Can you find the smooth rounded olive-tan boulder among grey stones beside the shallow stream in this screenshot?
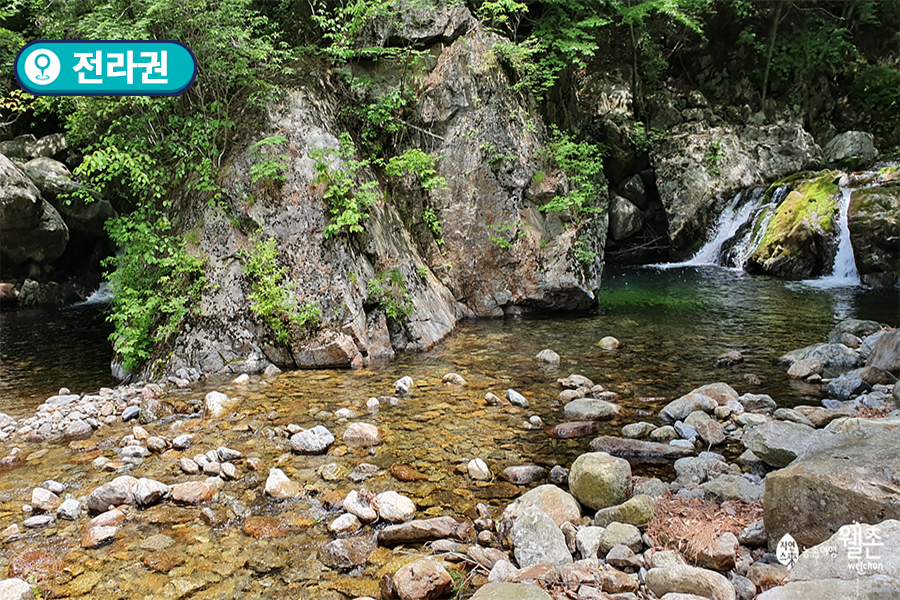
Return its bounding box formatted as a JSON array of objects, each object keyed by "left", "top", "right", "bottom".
[{"left": 569, "top": 452, "right": 631, "bottom": 510}]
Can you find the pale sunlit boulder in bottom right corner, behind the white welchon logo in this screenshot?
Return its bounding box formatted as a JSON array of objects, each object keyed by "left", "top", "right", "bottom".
[{"left": 758, "top": 519, "right": 900, "bottom": 600}]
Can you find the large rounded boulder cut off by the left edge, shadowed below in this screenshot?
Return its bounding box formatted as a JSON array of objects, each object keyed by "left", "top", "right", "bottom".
[{"left": 0, "top": 154, "right": 69, "bottom": 264}]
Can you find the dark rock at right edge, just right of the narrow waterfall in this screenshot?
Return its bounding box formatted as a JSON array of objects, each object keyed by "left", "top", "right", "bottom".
[{"left": 847, "top": 186, "right": 900, "bottom": 289}]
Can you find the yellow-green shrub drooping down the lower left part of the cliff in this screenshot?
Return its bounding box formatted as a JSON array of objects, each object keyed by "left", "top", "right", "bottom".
[{"left": 238, "top": 233, "right": 322, "bottom": 344}]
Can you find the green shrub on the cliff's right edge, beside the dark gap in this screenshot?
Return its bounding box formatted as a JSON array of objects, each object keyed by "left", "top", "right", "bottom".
[{"left": 541, "top": 127, "right": 603, "bottom": 217}]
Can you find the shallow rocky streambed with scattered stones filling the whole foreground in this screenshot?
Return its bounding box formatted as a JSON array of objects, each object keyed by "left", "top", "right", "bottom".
[{"left": 0, "top": 321, "right": 900, "bottom": 600}]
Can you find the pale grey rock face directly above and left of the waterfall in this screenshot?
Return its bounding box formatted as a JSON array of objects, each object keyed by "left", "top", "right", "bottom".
[{"left": 650, "top": 122, "right": 821, "bottom": 258}]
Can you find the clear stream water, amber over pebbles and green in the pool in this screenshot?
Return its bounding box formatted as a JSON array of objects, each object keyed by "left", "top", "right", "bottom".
[{"left": 0, "top": 266, "right": 900, "bottom": 600}]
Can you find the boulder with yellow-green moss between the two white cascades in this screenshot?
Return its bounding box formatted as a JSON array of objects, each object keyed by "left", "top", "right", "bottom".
[{"left": 747, "top": 171, "right": 840, "bottom": 279}]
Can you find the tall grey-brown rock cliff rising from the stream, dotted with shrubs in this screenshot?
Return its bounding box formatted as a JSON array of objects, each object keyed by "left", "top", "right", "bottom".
[{"left": 158, "top": 31, "right": 606, "bottom": 375}]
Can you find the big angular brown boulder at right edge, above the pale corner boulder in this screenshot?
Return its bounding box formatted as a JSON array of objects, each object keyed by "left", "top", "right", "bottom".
[{"left": 754, "top": 418, "right": 900, "bottom": 547}]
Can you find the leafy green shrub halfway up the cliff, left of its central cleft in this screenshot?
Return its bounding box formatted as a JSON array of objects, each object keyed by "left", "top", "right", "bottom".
[{"left": 310, "top": 132, "right": 380, "bottom": 238}]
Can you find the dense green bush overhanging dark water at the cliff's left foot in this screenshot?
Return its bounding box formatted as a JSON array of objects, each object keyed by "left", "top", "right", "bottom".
[{"left": 105, "top": 209, "right": 206, "bottom": 371}]
